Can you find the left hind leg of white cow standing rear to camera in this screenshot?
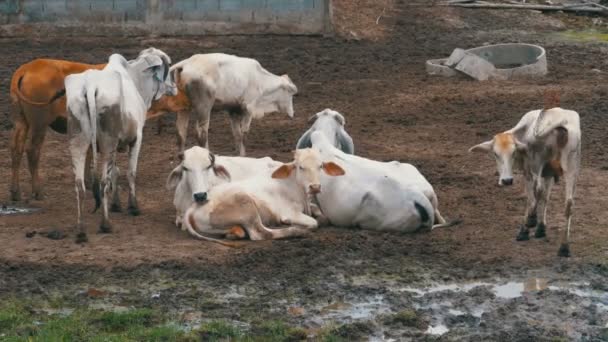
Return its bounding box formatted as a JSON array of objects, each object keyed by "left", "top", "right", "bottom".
[{"left": 69, "top": 133, "right": 90, "bottom": 243}]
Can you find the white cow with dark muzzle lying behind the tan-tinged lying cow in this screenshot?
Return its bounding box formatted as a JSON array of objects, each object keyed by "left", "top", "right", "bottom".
[{"left": 167, "top": 146, "right": 282, "bottom": 229}]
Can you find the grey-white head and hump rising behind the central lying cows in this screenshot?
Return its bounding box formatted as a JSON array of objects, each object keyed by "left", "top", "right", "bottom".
[{"left": 296, "top": 109, "right": 355, "bottom": 154}]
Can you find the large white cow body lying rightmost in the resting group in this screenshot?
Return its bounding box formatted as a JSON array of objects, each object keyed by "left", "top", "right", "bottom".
[{"left": 311, "top": 131, "right": 458, "bottom": 232}]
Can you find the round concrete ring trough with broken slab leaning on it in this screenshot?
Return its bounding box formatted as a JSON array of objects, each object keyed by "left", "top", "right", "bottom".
[{"left": 426, "top": 43, "right": 547, "bottom": 80}]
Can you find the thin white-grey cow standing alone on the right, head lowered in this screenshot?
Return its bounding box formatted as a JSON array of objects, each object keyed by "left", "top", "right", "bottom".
[{"left": 469, "top": 108, "right": 581, "bottom": 257}]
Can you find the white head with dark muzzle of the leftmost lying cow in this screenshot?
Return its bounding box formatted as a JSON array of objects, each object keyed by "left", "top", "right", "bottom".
[{"left": 167, "top": 146, "right": 230, "bottom": 204}]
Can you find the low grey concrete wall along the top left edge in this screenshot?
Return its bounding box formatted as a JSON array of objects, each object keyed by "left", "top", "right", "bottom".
[{"left": 0, "top": 0, "right": 331, "bottom": 35}]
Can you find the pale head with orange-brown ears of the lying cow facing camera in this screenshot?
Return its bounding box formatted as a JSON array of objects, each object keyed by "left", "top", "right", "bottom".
[{"left": 272, "top": 148, "right": 344, "bottom": 195}]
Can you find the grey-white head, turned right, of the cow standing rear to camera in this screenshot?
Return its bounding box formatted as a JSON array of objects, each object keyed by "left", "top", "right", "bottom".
[{"left": 136, "top": 48, "right": 177, "bottom": 100}]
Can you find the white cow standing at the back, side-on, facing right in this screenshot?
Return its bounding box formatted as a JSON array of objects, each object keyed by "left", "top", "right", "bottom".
[{"left": 149, "top": 53, "right": 298, "bottom": 156}]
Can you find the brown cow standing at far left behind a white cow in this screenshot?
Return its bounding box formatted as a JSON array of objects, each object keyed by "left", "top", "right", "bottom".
[{"left": 10, "top": 59, "right": 105, "bottom": 201}]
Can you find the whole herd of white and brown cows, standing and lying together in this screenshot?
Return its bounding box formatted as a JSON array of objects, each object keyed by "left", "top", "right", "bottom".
[{"left": 10, "top": 48, "right": 581, "bottom": 256}]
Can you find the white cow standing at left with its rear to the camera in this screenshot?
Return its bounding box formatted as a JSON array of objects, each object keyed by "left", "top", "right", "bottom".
[{"left": 65, "top": 48, "right": 177, "bottom": 242}]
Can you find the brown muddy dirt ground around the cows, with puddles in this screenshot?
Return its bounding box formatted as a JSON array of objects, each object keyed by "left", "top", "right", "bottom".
[{"left": 0, "top": 1, "right": 608, "bottom": 341}]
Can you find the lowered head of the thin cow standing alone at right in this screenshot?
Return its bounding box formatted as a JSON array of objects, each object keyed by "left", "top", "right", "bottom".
[{"left": 469, "top": 132, "right": 527, "bottom": 186}]
